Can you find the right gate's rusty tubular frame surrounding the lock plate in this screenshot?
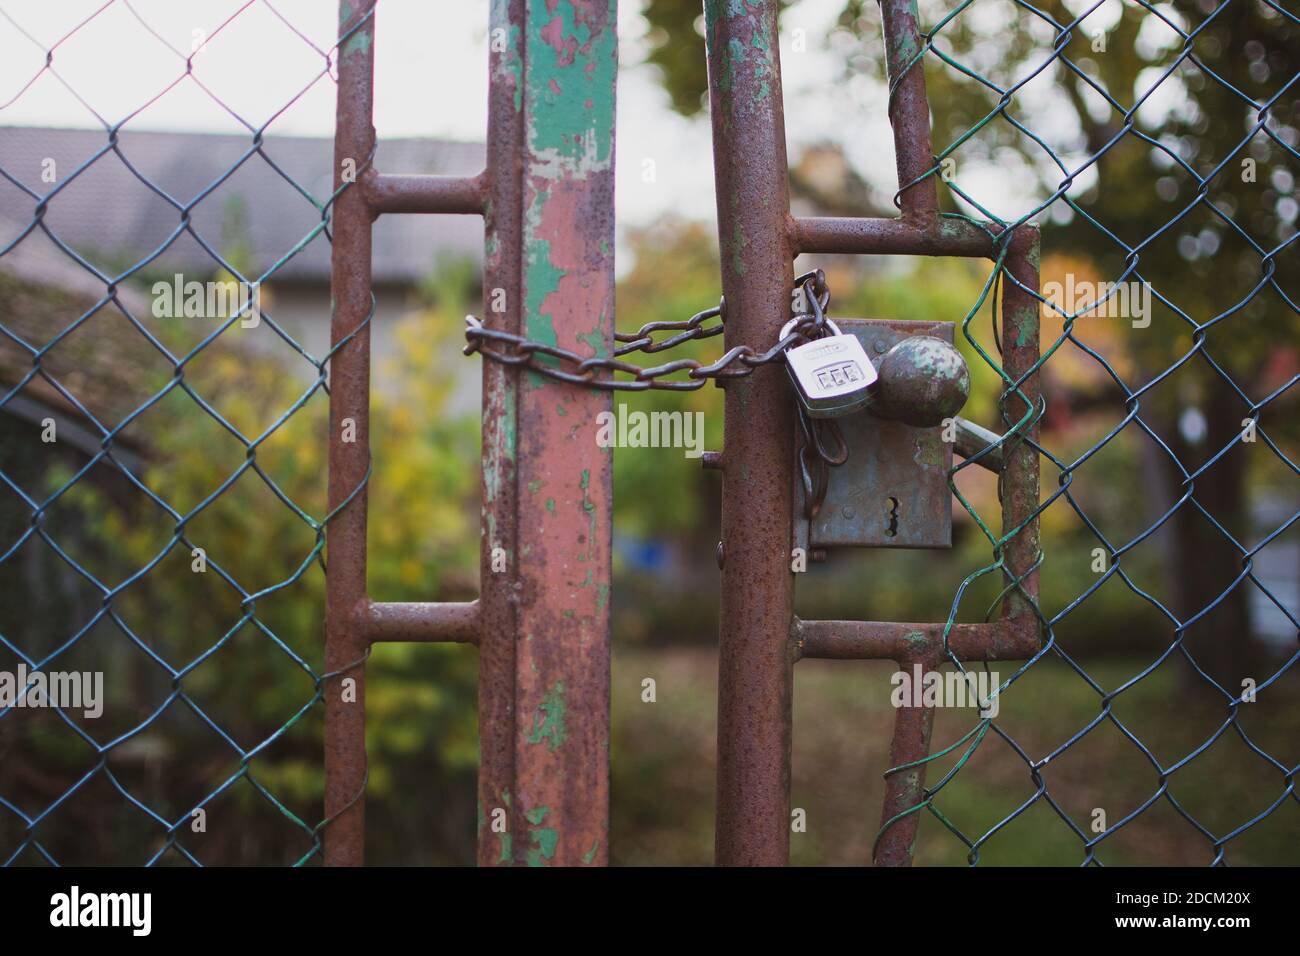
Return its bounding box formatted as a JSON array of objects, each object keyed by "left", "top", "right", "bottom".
[{"left": 705, "top": 0, "right": 1040, "bottom": 865}]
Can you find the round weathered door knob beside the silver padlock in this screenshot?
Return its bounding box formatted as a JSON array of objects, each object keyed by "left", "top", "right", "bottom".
[{"left": 871, "top": 336, "right": 971, "bottom": 428}]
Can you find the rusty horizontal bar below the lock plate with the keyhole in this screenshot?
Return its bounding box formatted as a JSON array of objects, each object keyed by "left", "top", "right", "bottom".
[{"left": 790, "top": 615, "right": 1041, "bottom": 661}]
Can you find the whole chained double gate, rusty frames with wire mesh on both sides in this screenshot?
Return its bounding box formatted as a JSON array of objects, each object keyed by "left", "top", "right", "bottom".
[{"left": 0, "top": 0, "right": 1300, "bottom": 866}]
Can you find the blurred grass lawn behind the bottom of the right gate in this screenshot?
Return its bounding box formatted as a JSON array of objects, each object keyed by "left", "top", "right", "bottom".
[{"left": 611, "top": 648, "right": 1300, "bottom": 865}]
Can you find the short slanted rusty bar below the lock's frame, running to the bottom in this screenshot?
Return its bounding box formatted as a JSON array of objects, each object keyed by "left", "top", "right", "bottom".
[{"left": 872, "top": 650, "right": 940, "bottom": 866}]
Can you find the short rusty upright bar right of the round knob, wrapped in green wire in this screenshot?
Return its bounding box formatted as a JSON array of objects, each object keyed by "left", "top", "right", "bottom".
[{"left": 998, "top": 230, "right": 1043, "bottom": 618}]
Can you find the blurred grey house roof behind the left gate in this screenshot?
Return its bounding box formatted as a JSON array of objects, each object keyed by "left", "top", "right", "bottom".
[{"left": 0, "top": 126, "right": 484, "bottom": 282}]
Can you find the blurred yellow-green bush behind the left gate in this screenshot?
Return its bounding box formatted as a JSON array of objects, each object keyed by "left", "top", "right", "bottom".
[{"left": 24, "top": 290, "right": 478, "bottom": 862}]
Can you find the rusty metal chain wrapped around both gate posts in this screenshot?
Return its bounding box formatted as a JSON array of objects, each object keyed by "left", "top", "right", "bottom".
[{"left": 464, "top": 269, "right": 849, "bottom": 520}]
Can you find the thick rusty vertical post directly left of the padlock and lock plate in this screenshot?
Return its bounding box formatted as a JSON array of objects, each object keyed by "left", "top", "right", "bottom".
[{"left": 705, "top": 0, "right": 794, "bottom": 865}]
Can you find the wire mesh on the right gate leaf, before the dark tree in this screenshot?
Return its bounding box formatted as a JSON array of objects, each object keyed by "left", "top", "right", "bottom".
[{"left": 873, "top": 0, "right": 1300, "bottom": 865}]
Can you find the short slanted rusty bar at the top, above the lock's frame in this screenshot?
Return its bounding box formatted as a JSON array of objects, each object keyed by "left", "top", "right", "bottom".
[{"left": 880, "top": 0, "right": 939, "bottom": 225}]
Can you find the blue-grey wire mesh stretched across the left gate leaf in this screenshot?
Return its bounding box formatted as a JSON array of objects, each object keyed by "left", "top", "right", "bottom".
[{"left": 0, "top": 0, "right": 368, "bottom": 865}]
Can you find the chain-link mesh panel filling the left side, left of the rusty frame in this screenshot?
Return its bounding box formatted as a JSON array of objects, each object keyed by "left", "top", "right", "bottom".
[{"left": 0, "top": 0, "right": 377, "bottom": 864}]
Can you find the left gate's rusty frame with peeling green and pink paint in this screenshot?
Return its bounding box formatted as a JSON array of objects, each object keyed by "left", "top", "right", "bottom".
[{"left": 324, "top": 0, "right": 618, "bottom": 865}]
